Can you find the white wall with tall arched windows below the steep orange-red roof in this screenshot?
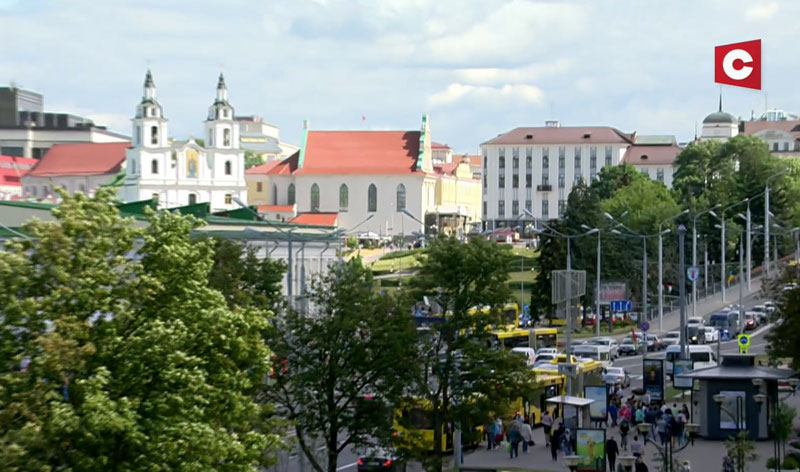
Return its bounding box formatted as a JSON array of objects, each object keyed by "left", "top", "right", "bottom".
[{"left": 270, "top": 173, "right": 436, "bottom": 236}]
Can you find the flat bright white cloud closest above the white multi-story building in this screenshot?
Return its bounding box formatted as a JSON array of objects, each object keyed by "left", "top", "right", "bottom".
[{"left": 428, "top": 83, "right": 544, "bottom": 108}]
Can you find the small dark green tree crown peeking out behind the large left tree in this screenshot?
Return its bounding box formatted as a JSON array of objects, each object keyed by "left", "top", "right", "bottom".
[{"left": 208, "top": 239, "right": 286, "bottom": 310}]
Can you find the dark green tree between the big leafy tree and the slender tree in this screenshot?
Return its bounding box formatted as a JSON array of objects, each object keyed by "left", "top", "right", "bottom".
[{"left": 264, "top": 258, "right": 416, "bottom": 472}]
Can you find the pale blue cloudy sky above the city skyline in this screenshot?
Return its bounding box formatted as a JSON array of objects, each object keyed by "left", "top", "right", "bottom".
[{"left": 0, "top": 0, "right": 800, "bottom": 152}]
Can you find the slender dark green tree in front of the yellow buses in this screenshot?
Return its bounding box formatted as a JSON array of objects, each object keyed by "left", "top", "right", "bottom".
[{"left": 411, "top": 237, "right": 532, "bottom": 471}]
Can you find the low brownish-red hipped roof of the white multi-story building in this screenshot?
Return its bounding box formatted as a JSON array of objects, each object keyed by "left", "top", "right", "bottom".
[{"left": 483, "top": 126, "right": 632, "bottom": 145}]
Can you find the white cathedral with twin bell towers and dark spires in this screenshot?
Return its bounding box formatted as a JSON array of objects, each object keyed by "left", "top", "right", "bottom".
[{"left": 120, "top": 70, "right": 247, "bottom": 211}]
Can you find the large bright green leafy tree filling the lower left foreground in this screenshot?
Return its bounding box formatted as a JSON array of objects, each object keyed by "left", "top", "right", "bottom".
[{"left": 0, "top": 189, "right": 279, "bottom": 471}]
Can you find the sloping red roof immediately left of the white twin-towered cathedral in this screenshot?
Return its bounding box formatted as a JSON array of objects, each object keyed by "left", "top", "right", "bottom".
[{"left": 28, "top": 143, "right": 131, "bottom": 177}]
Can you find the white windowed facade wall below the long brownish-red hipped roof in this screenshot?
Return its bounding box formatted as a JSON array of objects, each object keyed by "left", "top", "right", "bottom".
[{"left": 481, "top": 143, "right": 630, "bottom": 229}]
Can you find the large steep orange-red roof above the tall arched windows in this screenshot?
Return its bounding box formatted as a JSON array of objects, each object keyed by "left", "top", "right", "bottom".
[{"left": 292, "top": 131, "right": 420, "bottom": 175}]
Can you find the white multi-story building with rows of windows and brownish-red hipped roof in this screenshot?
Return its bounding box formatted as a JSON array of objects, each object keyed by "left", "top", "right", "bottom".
[{"left": 481, "top": 122, "right": 635, "bottom": 229}]
